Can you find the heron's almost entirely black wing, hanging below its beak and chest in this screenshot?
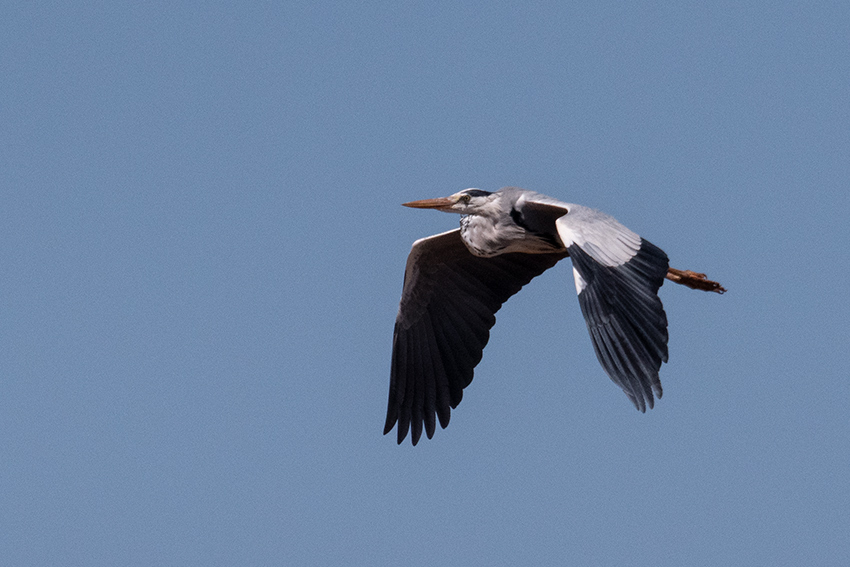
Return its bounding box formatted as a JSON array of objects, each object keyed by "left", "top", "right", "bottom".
[{"left": 384, "top": 229, "right": 566, "bottom": 445}]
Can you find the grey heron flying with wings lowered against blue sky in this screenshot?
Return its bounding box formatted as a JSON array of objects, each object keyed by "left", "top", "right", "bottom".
[{"left": 384, "top": 187, "right": 726, "bottom": 445}]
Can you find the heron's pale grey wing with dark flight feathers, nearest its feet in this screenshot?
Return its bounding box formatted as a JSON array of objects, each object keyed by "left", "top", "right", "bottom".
[{"left": 541, "top": 204, "right": 668, "bottom": 411}]
